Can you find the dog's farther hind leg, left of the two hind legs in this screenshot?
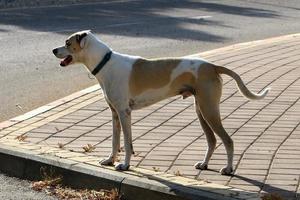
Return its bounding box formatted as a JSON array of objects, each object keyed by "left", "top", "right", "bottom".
[{"left": 195, "top": 101, "right": 217, "bottom": 170}]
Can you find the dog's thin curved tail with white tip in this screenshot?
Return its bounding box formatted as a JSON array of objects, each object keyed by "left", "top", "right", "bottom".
[{"left": 216, "top": 66, "right": 271, "bottom": 100}]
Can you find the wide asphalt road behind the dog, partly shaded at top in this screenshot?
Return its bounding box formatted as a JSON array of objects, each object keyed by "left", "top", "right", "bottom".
[{"left": 0, "top": 0, "right": 300, "bottom": 121}]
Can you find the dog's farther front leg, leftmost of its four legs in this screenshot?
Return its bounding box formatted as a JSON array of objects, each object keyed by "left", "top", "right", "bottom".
[{"left": 100, "top": 106, "right": 121, "bottom": 166}]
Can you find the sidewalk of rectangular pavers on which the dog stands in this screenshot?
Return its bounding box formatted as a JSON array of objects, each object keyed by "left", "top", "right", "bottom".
[{"left": 0, "top": 34, "right": 300, "bottom": 200}]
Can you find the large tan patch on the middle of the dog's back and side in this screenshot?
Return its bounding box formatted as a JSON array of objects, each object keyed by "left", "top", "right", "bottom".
[{"left": 129, "top": 58, "right": 181, "bottom": 96}]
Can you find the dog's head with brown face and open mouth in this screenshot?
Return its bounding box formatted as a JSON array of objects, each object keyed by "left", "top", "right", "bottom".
[{"left": 52, "top": 30, "right": 91, "bottom": 67}]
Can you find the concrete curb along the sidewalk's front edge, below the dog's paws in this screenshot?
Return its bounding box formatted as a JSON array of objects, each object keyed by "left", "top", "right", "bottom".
[{"left": 0, "top": 140, "right": 259, "bottom": 200}]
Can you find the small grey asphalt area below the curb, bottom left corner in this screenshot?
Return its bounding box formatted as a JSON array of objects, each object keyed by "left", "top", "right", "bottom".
[{"left": 0, "top": 174, "right": 57, "bottom": 200}]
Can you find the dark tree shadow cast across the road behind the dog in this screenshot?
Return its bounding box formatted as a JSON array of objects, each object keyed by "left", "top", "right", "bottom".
[{"left": 0, "top": 0, "right": 279, "bottom": 42}]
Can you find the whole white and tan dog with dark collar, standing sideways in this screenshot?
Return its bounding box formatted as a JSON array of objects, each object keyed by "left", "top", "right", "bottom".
[{"left": 53, "top": 31, "right": 269, "bottom": 174}]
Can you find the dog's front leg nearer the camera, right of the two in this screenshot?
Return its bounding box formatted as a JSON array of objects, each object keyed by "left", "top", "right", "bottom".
[{"left": 115, "top": 108, "right": 133, "bottom": 171}]
